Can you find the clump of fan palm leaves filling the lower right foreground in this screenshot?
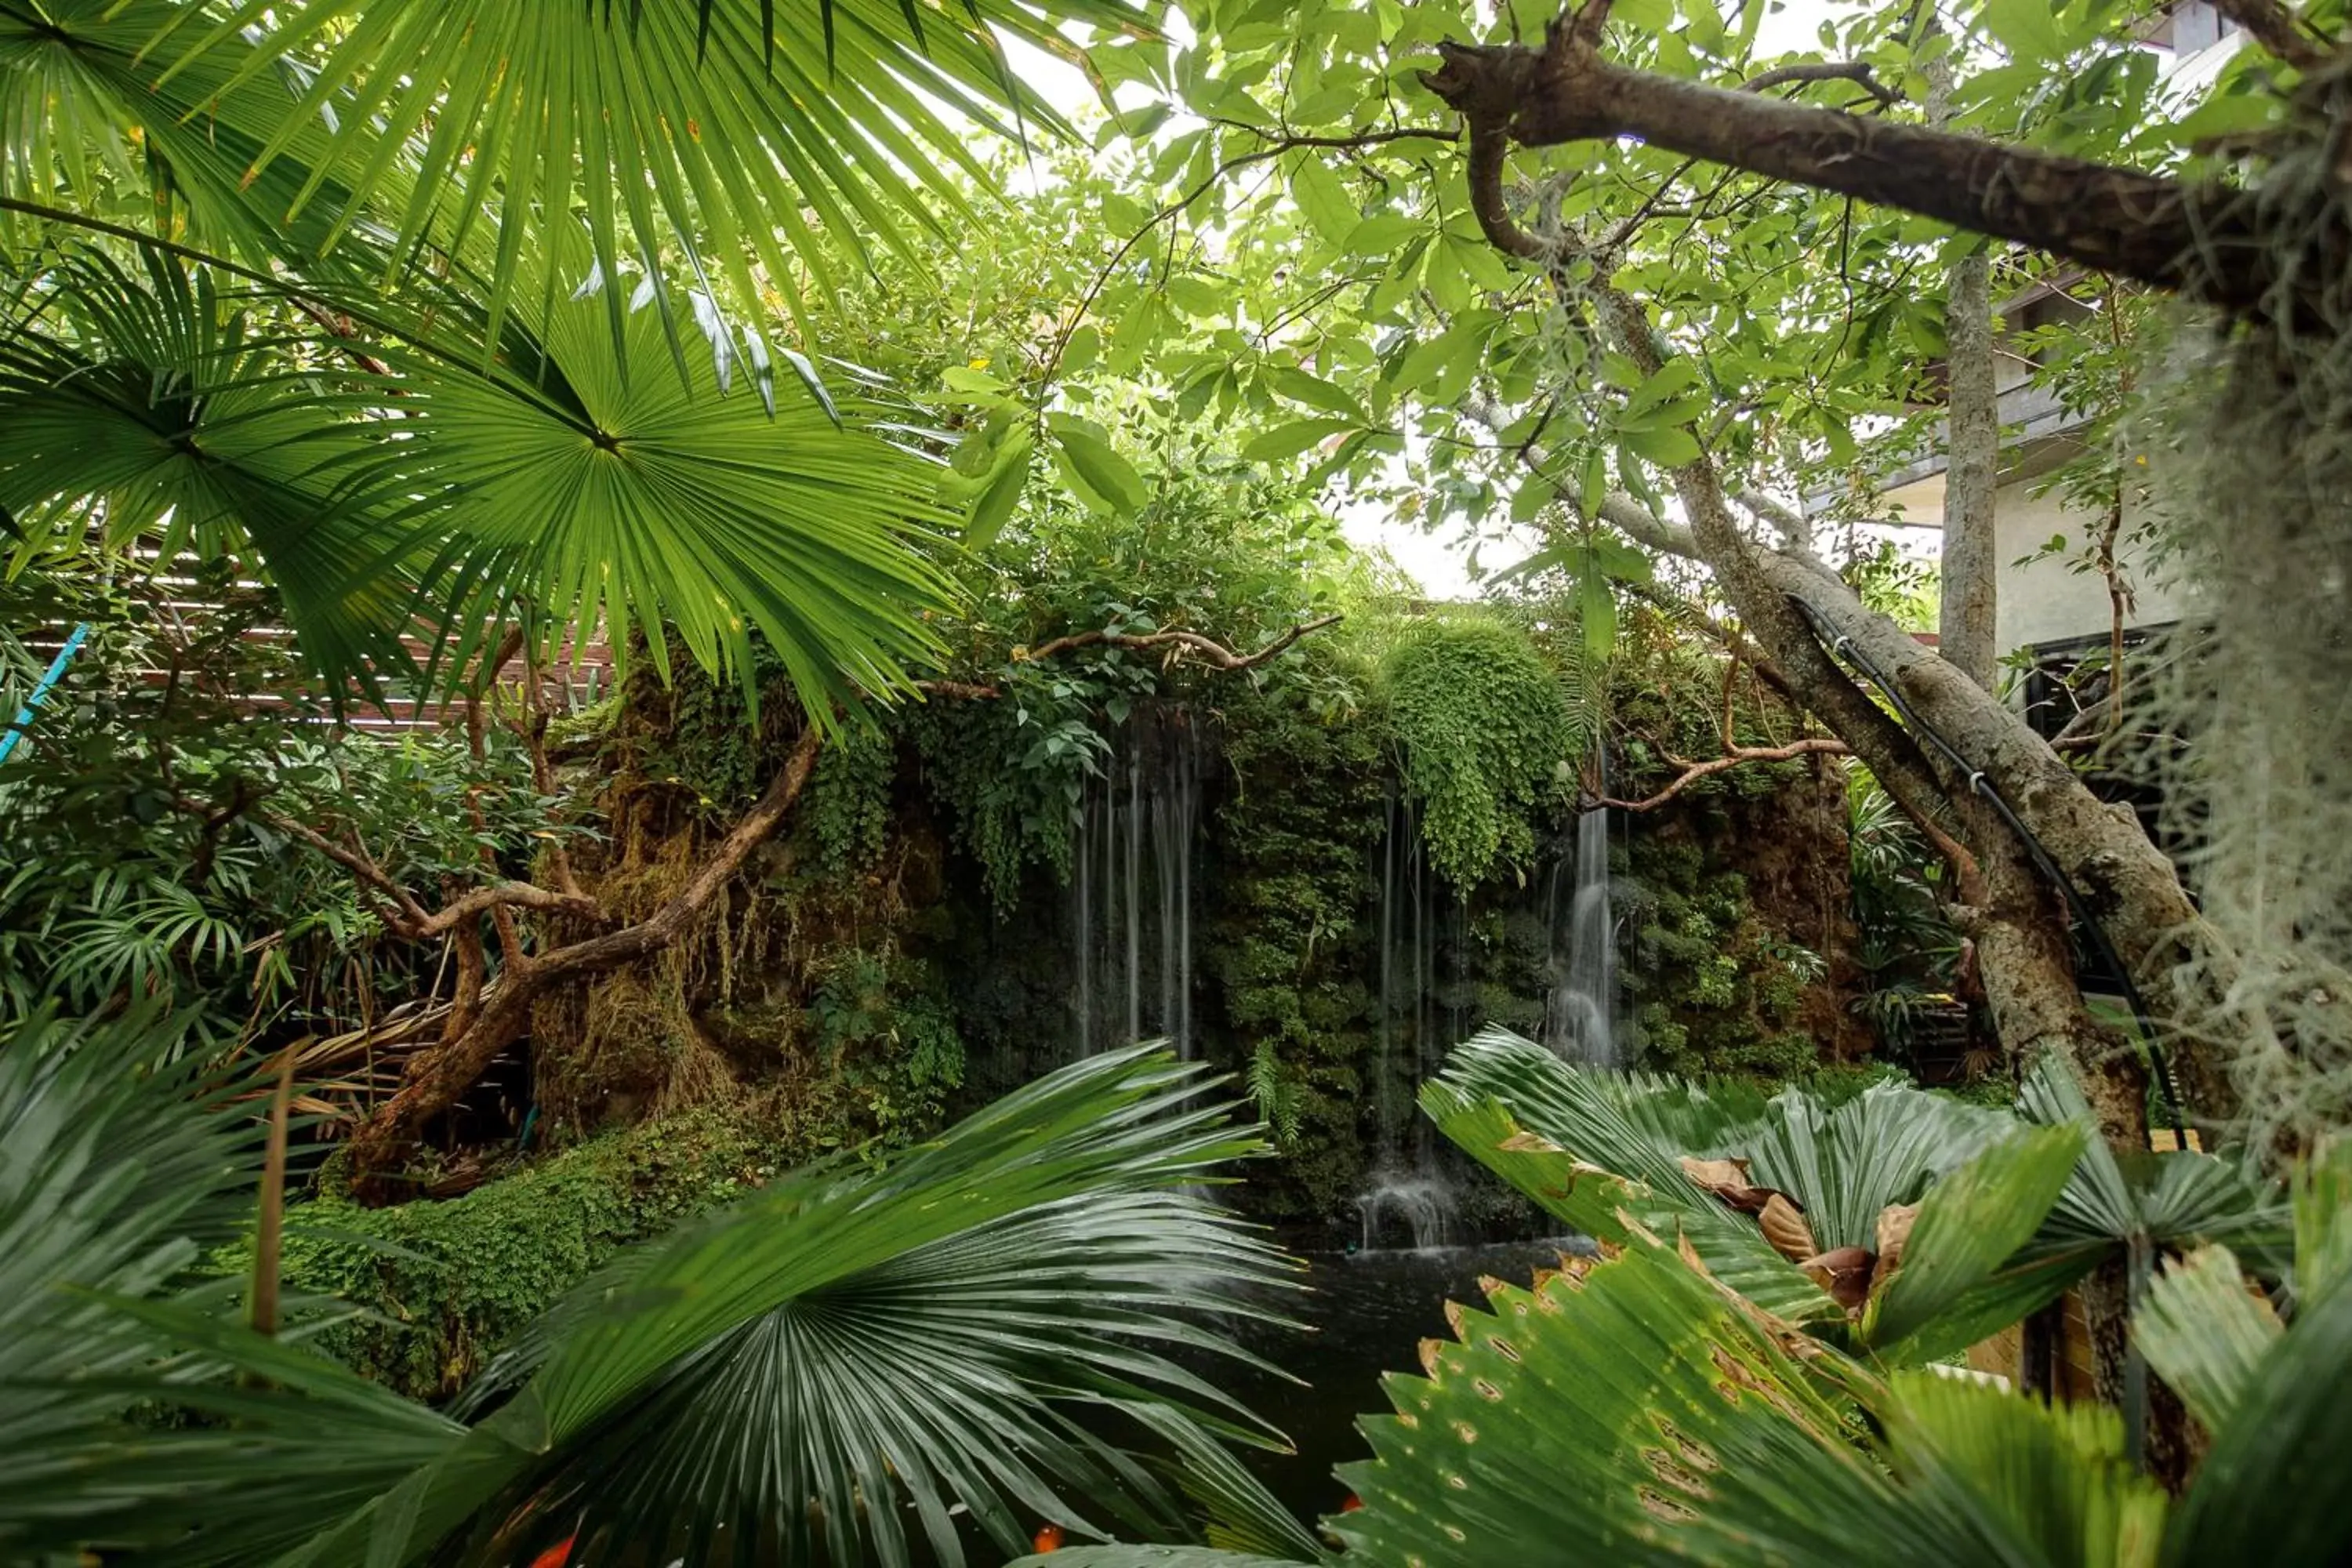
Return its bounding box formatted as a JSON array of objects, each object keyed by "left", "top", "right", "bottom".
[{"left": 1030, "top": 1036, "right": 2352, "bottom": 1568}]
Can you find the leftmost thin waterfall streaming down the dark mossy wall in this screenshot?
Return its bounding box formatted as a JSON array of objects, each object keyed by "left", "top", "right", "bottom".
[{"left": 1070, "top": 713, "right": 1200, "bottom": 1060}]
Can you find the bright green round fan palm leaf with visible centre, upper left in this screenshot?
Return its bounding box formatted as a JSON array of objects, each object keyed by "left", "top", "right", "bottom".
[{"left": 381, "top": 281, "right": 953, "bottom": 722}]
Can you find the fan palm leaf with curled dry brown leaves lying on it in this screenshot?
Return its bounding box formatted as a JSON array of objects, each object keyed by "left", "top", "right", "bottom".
[{"left": 1421, "top": 1029, "right": 2091, "bottom": 1363}]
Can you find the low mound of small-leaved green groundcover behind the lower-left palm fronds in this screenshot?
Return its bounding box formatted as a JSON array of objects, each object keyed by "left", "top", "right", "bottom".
[{"left": 266, "top": 1109, "right": 809, "bottom": 1399}]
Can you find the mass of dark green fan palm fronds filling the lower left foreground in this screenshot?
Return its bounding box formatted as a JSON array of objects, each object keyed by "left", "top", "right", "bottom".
[{"left": 0, "top": 1029, "right": 1296, "bottom": 1563}]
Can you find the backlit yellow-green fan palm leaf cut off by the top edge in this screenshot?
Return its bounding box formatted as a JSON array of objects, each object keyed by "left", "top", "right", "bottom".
[{"left": 132, "top": 0, "right": 1141, "bottom": 338}]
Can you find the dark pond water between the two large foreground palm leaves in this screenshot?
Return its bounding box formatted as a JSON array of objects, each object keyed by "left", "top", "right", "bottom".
[{"left": 1225, "top": 1239, "right": 1588, "bottom": 1519}]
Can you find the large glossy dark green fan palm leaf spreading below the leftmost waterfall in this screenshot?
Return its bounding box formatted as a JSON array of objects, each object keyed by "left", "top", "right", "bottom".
[{"left": 36, "top": 1048, "right": 1291, "bottom": 1566}]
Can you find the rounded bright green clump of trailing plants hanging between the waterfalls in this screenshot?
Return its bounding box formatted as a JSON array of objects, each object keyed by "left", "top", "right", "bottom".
[{"left": 1378, "top": 616, "right": 1573, "bottom": 888}]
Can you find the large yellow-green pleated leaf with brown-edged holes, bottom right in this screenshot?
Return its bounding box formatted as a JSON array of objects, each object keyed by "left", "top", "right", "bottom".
[{"left": 1327, "top": 1239, "right": 1891, "bottom": 1568}]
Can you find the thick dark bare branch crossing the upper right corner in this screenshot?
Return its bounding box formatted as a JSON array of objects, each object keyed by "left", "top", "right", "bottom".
[{"left": 1425, "top": 20, "right": 2286, "bottom": 313}]
